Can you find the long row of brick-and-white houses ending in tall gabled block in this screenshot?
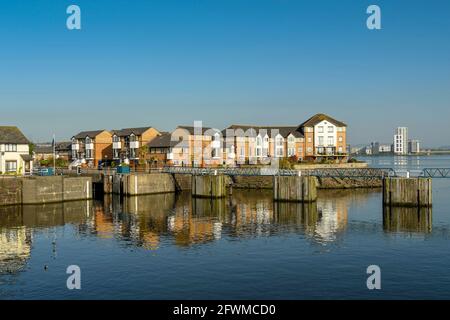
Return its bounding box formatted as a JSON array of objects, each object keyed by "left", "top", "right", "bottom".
[{"left": 149, "top": 114, "right": 347, "bottom": 167}]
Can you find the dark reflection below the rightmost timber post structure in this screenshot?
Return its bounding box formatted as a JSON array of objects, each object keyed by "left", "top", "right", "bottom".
[{"left": 383, "top": 206, "right": 432, "bottom": 234}]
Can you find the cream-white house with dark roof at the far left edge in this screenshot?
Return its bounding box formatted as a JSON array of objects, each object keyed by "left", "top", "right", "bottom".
[{"left": 0, "top": 126, "right": 33, "bottom": 174}]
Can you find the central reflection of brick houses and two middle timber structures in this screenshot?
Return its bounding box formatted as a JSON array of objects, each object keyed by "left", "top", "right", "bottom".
[{"left": 87, "top": 190, "right": 364, "bottom": 250}]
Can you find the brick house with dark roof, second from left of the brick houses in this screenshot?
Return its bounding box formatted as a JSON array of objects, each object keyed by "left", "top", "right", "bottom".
[{"left": 112, "top": 127, "right": 160, "bottom": 165}]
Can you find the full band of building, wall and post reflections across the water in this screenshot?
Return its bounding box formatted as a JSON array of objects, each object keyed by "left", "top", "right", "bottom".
[{"left": 0, "top": 190, "right": 432, "bottom": 273}]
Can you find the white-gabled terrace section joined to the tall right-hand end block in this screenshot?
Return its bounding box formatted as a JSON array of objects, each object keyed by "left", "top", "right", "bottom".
[{"left": 222, "top": 114, "right": 347, "bottom": 164}]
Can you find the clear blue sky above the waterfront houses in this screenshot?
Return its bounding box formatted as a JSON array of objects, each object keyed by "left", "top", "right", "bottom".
[{"left": 0, "top": 0, "right": 450, "bottom": 146}]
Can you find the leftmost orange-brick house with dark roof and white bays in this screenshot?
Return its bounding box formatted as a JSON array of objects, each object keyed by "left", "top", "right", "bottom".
[{"left": 72, "top": 130, "right": 113, "bottom": 168}]
